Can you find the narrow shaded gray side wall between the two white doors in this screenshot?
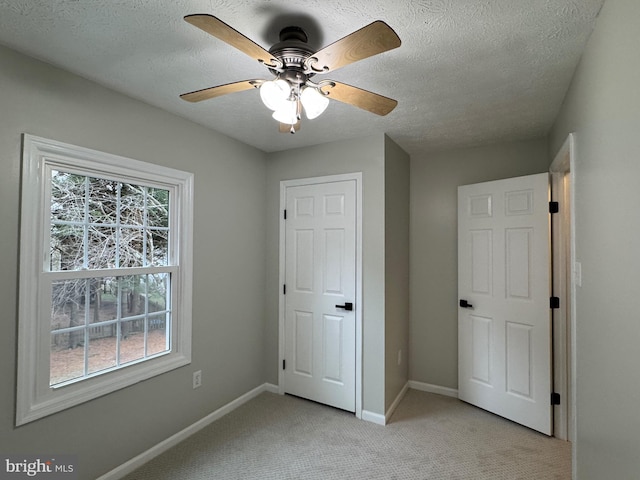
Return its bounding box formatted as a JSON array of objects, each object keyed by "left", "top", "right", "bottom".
[{"left": 384, "top": 137, "right": 409, "bottom": 411}]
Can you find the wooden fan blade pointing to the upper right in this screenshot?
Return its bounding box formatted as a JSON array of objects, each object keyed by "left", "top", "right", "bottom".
[{"left": 309, "top": 20, "right": 401, "bottom": 72}]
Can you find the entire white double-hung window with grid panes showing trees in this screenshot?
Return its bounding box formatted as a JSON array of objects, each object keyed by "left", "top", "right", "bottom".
[{"left": 16, "top": 135, "right": 193, "bottom": 425}]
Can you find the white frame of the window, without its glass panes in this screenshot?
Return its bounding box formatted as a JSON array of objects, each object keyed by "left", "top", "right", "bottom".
[{"left": 16, "top": 134, "right": 194, "bottom": 425}]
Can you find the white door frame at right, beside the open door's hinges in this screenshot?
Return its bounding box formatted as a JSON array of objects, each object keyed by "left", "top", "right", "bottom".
[{"left": 549, "top": 133, "right": 577, "bottom": 446}]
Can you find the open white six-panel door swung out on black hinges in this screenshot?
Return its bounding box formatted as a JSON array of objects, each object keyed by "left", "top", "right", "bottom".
[{"left": 458, "top": 173, "right": 553, "bottom": 435}]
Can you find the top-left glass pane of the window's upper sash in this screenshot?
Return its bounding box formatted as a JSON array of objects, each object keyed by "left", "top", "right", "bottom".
[{"left": 51, "top": 170, "right": 86, "bottom": 222}]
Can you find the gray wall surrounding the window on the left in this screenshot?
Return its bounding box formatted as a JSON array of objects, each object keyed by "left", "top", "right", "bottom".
[{"left": 0, "top": 47, "right": 266, "bottom": 479}]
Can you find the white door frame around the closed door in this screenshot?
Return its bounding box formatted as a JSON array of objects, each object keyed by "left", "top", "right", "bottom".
[{"left": 278, "top": 172, "right": 363, "bottom": 418}]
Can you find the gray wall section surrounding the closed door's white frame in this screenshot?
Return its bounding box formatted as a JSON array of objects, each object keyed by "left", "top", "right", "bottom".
[{"left": 264, "top": 135, "right": 385, "bottom": 414}]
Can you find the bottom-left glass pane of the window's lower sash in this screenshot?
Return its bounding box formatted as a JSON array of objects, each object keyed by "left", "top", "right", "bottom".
[{"left": 49, "top": 331, "right": 84, "bottom": 385}]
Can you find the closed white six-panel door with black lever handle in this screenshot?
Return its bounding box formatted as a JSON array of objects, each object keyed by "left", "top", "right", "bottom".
[{"left": 284, "top": 180, "right": 359, "bottom": 412}]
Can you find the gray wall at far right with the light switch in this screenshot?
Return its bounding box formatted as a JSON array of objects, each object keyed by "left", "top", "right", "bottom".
[{"left": 550, "top": 0, "right": 640, "bottom": 474}]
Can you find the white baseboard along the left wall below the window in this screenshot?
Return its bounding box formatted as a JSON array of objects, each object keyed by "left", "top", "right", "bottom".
[{"left": 97, "top": 383, "right": 279, "bottom": 480}]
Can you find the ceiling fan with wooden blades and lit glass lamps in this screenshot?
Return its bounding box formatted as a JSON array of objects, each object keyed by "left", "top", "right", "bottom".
[{"left": 180, "top": 14, "right": 401, "bottom": 133}]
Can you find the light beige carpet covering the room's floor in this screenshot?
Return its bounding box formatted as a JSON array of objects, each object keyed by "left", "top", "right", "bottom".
[{"left": 120, "top": 390, "right": 571, "bottom": 480}]
